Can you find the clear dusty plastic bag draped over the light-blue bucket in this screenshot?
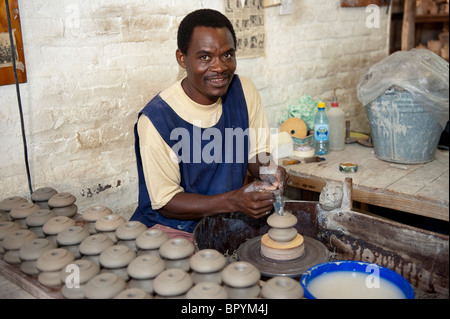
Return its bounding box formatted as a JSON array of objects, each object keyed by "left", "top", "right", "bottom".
[{"left": 357, "top": 49, "right": 449, "bottom": 128}]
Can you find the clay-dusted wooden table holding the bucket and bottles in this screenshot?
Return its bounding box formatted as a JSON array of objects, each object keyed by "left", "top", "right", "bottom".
[{"left": 280, "top": 143, "right": 449, "bottom": 221}]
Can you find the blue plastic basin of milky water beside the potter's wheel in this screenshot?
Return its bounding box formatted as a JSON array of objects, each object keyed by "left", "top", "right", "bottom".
[{"left": 300, "top": 260, "right": 414, "bottom": 299}]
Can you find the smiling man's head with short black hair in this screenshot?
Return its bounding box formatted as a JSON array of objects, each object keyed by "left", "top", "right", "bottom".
[{"left": 176, "top": 9, "right": 236, "bottom": 105}]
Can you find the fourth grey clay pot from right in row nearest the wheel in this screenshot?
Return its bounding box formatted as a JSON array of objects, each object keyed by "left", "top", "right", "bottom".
[{"left": 159, "top": 237, "right": 195, "bottom": 272}]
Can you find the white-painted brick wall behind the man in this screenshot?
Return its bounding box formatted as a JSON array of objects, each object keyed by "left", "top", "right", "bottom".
[{"left": 0, "top": 0, "right": 389, "bottom": 217}]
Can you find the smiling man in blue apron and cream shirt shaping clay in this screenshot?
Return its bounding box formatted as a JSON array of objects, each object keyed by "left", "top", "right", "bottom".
[{"left": 131, "top": 9, "right": 288, "bottom": 238}]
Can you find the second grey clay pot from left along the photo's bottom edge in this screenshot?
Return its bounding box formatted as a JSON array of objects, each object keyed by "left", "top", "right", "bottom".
[{"left": 84, "top": 272, "right": 126, "bottom": 299}]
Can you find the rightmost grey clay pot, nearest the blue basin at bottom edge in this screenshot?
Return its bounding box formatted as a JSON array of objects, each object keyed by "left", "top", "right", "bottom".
[{"left": 261, "top": 277, "right": 303, "bottom": 299}]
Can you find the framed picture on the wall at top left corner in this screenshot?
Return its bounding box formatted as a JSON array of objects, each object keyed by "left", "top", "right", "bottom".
[{"left": 0, "top": 0, "right": 27, "bottom": 85}]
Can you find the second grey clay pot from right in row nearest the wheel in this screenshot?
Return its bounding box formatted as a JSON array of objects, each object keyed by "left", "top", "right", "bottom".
[{"left": 222, "top": 261, "right": 261, "bottom": 288}]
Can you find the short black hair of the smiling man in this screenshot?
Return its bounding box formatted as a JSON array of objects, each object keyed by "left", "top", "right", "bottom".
[{"left": 177, "top": 9, "right": 237, "bottom": 54}]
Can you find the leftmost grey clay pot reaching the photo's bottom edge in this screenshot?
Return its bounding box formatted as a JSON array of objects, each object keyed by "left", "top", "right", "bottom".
[{"left": 60, "top": 259, "right": 100, "bottom": 299}]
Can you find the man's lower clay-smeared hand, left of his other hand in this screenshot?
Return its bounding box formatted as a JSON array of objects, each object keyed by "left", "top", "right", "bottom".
[{"left": 233, "top": 181, "right": 276, "bottom": 218}]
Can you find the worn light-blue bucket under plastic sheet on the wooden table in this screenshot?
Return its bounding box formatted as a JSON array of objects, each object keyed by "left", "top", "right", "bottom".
[{"left": 366, "top": 89, "right": 442, "bottom": 164}]
